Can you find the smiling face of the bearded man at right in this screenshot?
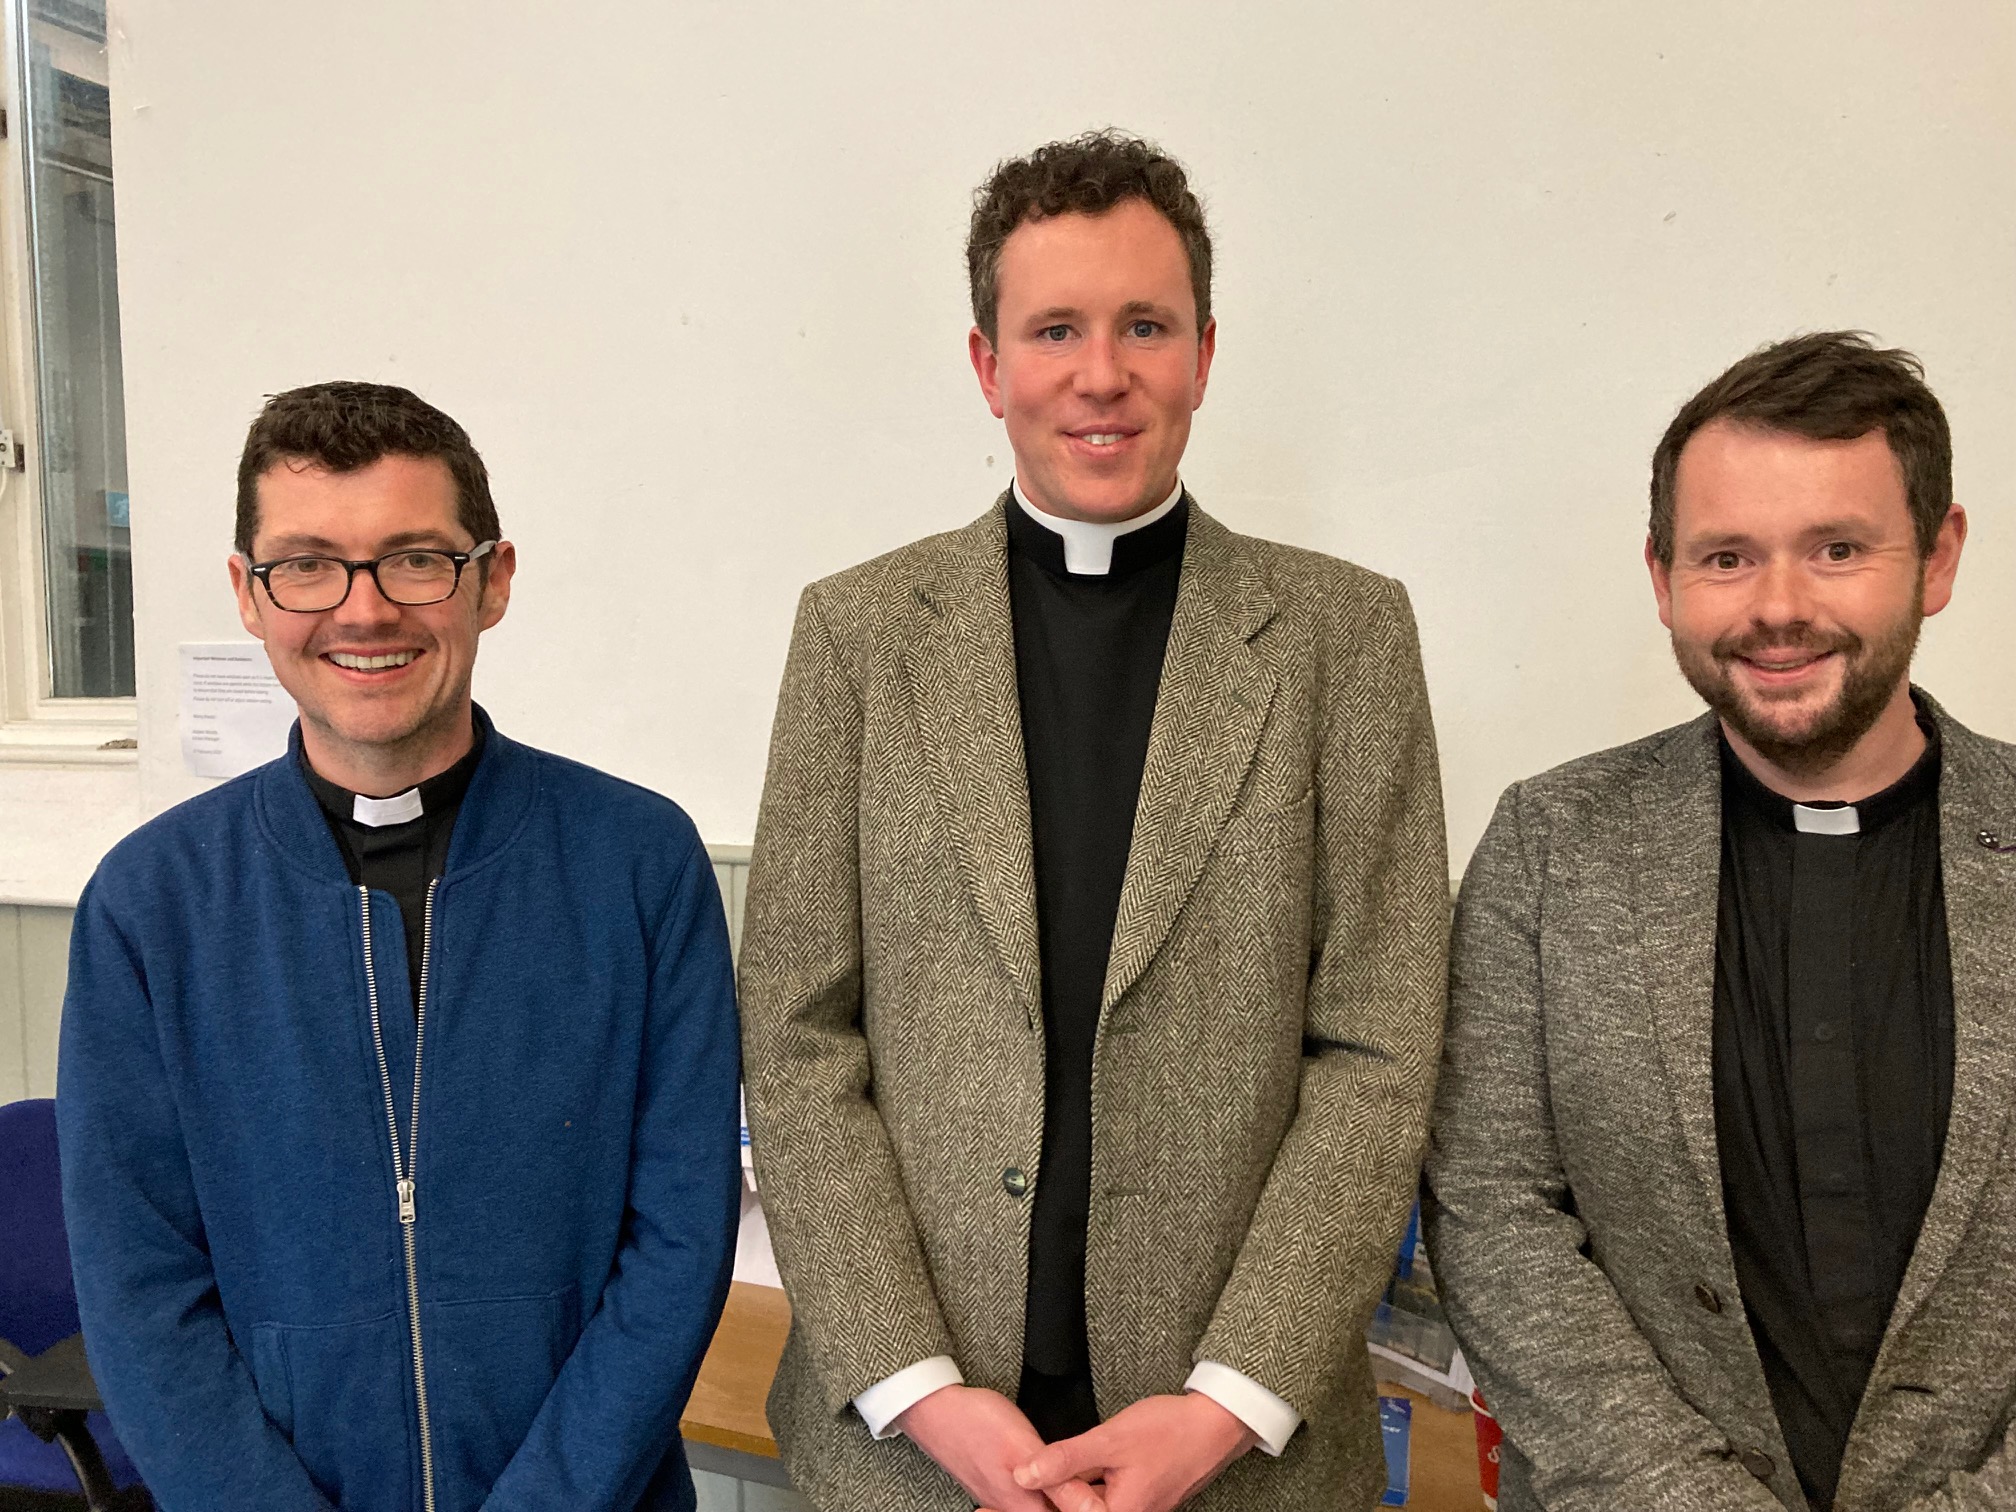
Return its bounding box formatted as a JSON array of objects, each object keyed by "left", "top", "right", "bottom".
[{"left": 1647, "top": 419, "right": 1966, "bottom": 796}]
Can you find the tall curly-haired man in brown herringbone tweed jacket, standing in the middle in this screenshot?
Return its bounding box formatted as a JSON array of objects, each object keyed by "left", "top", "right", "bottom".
[{"left": 742, "top": 133, "right": 1445, "bottom": 1512}]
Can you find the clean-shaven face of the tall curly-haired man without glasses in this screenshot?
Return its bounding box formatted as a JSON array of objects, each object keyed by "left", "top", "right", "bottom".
[{"left": 968, "top": 200, "right": 1218, "bottom": 522}]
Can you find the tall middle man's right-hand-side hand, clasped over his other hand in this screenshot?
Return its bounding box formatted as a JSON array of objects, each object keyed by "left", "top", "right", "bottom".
[{"left": 1000, "top": 1391, "right": 1260, "bottom": 1512}]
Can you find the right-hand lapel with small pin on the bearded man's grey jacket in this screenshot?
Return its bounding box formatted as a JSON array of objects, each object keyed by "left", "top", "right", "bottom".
[{"left": 1891, "top": 694, "right": 2016, "bottom": 1335}]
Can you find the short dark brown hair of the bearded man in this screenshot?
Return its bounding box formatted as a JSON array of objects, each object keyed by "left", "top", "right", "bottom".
[{"left": 1651, "top": 331, "right": 1954, "bottom": 566}]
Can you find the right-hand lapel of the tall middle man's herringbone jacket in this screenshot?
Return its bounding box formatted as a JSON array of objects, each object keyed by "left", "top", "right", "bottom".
[{"left": 1099, "top": 502, "right": 1274, "bottom": 1016}]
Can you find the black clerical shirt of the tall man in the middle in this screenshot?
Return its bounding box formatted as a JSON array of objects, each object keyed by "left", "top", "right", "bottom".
[{"left": 1008, "top": 498, "right": 1189, "bottom": 1377}]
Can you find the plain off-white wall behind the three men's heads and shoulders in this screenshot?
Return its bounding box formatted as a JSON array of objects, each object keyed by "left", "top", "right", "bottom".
[{"left": 23, "top": 0, "right": 2016, "bottom": 895}]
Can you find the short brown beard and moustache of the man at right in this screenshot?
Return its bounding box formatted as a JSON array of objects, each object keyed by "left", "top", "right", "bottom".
[{"left": 1673, "top": 591, "right": 1925, "bottom": 776}]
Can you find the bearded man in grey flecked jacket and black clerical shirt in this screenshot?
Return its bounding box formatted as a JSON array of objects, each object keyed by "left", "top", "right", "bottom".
[{"left": 1427, "top": 333, "right": 2016, "bottom": 1512}]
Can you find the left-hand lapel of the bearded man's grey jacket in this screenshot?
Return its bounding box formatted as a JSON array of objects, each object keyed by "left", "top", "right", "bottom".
[{"left": 1631, "top": 714, "right": 1736, "bottom": 1241}]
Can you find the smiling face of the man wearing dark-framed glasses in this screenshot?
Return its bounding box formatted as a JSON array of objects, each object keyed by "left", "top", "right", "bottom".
[{"left": 230, "top": 454, "right": 516, "bottom": 794}]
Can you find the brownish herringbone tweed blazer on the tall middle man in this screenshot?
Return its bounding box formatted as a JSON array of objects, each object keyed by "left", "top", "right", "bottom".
[{"left": 742, "top": 504, "right": 1447, "bottom": 1512}]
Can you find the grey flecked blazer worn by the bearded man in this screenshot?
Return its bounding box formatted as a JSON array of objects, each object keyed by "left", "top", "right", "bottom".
[{"left": 1427, "top": 700, "right": 2016, "bottom": 1512}]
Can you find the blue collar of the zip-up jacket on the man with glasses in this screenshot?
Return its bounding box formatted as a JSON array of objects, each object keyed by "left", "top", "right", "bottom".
[{"left": 252, "top": 706, "right": 538, "bottom": 887}]
